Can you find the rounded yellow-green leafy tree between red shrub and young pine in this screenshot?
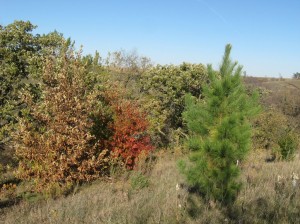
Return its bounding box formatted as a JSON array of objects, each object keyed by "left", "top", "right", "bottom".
[{"left": 140, "top": 63, "right": 208, "bottom": 145}]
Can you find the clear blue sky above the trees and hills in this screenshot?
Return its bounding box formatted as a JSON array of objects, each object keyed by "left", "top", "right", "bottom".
[{"left": 0, "top": 0, "right": 300, "bottom": 77}]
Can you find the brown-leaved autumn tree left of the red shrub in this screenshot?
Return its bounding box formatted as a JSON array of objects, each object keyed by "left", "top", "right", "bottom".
[{"left": 15, "top": 47, "right": 109, "bottom": 190}]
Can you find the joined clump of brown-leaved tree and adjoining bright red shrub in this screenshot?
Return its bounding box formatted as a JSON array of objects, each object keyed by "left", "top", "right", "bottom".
[{"left": 10, "top": 41, "right": 153, "bottom": 196}]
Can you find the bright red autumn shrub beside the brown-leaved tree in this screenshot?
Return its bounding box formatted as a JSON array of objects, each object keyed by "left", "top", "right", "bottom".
[{"left": 102, "top": 90, "right": 153, "bottom": 169}]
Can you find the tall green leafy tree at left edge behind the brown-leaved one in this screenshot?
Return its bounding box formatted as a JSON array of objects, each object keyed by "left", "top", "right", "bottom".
[{"left": 0, "top": 21, "right": 64, "bottom": 149}]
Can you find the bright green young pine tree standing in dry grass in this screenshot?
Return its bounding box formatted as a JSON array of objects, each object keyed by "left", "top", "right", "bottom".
[{"left": 182, "top": 44, "right": 258, "bottom": 205}]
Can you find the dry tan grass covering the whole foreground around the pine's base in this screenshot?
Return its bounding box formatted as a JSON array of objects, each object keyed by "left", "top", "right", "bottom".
[{"left": 0, "top": 150, "right": 300, "bottom": 224}]
